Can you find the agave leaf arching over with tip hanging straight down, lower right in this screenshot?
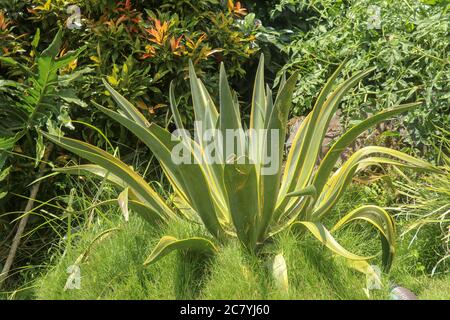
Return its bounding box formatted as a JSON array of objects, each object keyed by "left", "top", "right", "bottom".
[{"left": 331, "top": 205, "right": 395, "bottom": 271}]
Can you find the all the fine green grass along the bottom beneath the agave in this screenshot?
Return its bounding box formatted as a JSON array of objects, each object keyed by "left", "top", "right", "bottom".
[{"left": 24, "top": 180, "right": 450, "bottom": 300}]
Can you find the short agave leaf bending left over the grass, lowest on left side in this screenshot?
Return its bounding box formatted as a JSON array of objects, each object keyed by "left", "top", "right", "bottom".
[{"left": 144, "top": 236, "right": 217, "bottom": 266}]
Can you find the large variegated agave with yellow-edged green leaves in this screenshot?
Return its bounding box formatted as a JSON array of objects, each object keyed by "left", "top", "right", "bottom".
[{"left": 42, "top": 56, "right": 433, "bottom": 271}]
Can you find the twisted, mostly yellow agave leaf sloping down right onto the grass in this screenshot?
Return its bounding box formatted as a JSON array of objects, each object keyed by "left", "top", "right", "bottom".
[{"left": 291, "top": 221, "right": 375, "bottom": 260}]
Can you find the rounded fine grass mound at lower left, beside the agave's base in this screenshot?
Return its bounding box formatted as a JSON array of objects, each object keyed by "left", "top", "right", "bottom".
[{"left": 36, "top": 218, "right": 169, "bottom": 299}]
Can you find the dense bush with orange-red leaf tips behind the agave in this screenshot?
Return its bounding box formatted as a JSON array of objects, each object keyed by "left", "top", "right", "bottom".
[{"left": 5, "top": 0, "right": 258, "bottom": 129}]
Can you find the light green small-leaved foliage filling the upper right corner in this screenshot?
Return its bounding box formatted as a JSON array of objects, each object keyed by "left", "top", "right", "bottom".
[{"left": 273, "top": 0, "right": 450, "bottom": 157}]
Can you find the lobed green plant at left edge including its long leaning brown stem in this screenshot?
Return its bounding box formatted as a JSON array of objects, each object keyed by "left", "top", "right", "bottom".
[{"left": 0, "top": 29, "right": 85, "bottom": 285}]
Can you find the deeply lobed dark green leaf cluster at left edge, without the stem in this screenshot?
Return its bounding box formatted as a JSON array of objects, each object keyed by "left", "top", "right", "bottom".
[{"left": 0, "top": 30, "right": 85, "bottom": 190}]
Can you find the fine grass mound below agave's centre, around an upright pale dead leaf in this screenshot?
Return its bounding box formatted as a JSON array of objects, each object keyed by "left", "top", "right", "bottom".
[{"left": 201, "top": 232, "right": 384, "bottom": 300}]
